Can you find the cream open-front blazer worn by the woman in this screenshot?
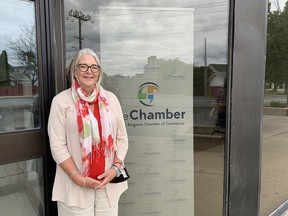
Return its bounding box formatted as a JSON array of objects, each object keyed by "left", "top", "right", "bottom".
[{"left": 48, "top": 88, "right": 128, "bottom": 208}]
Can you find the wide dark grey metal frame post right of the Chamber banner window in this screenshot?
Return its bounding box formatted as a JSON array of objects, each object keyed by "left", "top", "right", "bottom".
[{"left": 224, "top": 0, "right": 268, "bottom": 216}]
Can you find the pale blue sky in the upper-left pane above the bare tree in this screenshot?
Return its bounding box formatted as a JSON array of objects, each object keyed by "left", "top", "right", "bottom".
[{"left": 0, "top": 0, "right": 35, "bottom": 66}]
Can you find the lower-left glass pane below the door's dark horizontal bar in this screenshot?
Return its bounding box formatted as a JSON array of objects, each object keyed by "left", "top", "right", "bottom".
[{"left": 0, "top": 158, "right": 44, "bottom": 216}]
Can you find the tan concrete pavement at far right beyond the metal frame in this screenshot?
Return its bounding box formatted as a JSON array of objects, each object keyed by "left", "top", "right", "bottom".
[{"left": 260, "top": 115, "right": 288, "bottom": 216}]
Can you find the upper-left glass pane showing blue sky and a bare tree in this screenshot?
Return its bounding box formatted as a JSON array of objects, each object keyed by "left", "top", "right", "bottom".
[{"left": 0, "top": 0, "right": 40, "bottom": 133}]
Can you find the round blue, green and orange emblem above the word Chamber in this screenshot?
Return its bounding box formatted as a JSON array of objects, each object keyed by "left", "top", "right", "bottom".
[{"left": 138, "top": 82, "right": 159, "bottom": 106}]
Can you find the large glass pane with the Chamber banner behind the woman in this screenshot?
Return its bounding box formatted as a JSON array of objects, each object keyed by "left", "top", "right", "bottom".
[{"left": 64, "top": 0, "right": 229, "bottom": 216}]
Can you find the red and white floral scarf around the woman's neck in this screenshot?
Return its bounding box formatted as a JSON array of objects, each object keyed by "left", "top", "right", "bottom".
[{"left": 72, "top": 80, "right": 114, "bottom": 176}]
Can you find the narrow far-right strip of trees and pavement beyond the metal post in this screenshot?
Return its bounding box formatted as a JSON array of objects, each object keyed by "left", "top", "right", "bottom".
[{"left": 260, "top": 0, "right": 288, "bottom": 215}]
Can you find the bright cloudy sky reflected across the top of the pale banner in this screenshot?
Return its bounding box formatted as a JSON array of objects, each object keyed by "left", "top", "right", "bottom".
[{"left": 99, "top": 6, "right": 194, "bottom": 76}]
